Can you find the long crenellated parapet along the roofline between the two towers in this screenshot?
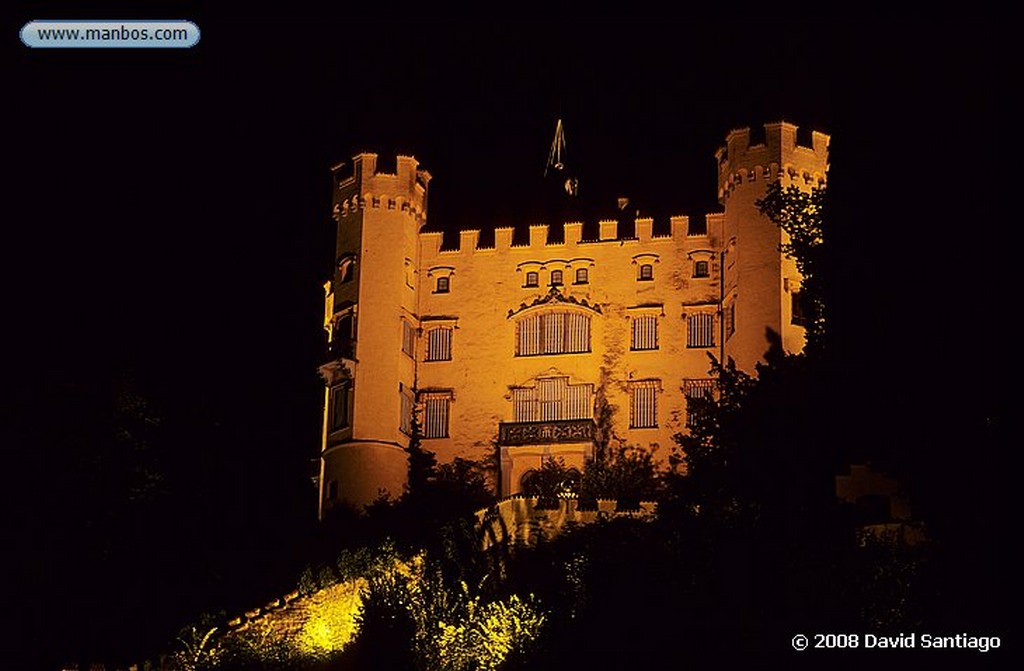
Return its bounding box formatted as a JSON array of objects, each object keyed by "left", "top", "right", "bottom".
[{"left": 420, "top": 214, "right": 721, "bottom": 256}]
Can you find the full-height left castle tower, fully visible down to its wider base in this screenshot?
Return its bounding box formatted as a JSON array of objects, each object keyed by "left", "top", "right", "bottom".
[{"left": 319, "top": 154, "right": 430, "bottom": 517}]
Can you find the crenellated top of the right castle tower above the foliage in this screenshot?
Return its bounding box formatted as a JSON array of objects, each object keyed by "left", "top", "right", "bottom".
[{"left": 715, "top": 121, "right": 829, "bottom": 205}]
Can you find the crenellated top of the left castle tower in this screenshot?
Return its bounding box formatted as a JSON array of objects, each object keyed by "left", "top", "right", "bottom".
[{"left": 332, "top": 153, "right": 430, "bottom": 223}]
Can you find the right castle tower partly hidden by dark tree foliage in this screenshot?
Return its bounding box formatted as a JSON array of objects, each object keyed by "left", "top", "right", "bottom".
[{"left": 716, "top": 122, "right": 828, "bottom": 372}]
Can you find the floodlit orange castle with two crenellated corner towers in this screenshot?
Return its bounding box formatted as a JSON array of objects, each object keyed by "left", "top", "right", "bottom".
[{"left": 318, "top": 122, "right": 828, "bottom": 517}]
